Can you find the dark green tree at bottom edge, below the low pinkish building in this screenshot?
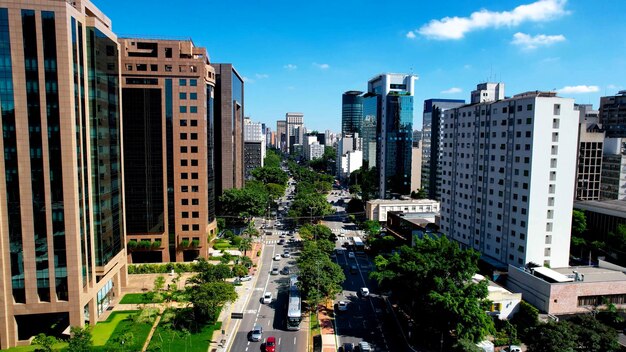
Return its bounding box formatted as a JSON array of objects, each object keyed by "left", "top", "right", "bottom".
[{"left": 525, "top": 321, "right": 576, "bottom": 352}]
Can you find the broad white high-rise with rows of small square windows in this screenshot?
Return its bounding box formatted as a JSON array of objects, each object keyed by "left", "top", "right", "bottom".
[{"left": 441, "top": 91, "right": 578, "bottom": 267}]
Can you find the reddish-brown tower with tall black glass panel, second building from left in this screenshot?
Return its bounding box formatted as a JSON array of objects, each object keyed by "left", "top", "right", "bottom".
[{"left": 119, "top": 38, "right": 217, "bottom": 263}]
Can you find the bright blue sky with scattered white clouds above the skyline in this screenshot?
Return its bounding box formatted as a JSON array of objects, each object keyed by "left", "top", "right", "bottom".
[{"left": 93, "top": 0, "right": 626, "bottom": 131}]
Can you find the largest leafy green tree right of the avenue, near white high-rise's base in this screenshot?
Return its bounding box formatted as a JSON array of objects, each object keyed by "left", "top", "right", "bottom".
[{"left": 370, "top": 236, "right": 494, "bottom": 342}]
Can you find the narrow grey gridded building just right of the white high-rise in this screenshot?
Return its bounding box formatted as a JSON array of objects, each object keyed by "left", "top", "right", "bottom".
[{"left": 574, "top": 104, "right": 604, "bottom": 200}]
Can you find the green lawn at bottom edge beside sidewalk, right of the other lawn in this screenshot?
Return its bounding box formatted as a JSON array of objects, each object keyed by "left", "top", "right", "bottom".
[{"left": 148, "top": 310, "right": 222, "bottom": 352}]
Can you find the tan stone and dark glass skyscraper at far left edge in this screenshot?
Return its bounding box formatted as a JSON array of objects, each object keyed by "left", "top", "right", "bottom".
[{"left": 0, "top": 0, "right": 126, "bottom": 349}]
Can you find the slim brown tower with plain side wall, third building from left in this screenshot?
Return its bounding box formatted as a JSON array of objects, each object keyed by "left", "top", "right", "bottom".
[{"left": 212, "top": 64, "right": 244, "bottom": 197}]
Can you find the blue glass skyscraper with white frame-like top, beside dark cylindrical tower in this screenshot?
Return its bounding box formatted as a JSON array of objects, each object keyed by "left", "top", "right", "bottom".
[{"left": 367, "top": 73, "right": 417, "bottom": 198}]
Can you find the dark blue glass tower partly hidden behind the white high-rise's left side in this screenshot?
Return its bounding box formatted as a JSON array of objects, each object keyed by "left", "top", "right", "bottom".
[{"left": 420, "top": 99, "right": 465, "bottom": 199}]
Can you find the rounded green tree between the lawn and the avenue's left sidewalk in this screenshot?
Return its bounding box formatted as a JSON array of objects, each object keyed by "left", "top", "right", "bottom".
[{"left": 189, "top": 282, "right": 237, "bottom": 323}]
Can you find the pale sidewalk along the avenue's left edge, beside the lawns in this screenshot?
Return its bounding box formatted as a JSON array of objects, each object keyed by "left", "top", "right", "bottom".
[{"left": 209, "top": 242, "right": 263, "bottom": 352}]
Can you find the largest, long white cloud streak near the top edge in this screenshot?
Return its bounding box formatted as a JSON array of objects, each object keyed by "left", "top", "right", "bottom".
[{"left": 417, "top": 0, "right": 567, "bottom": 40}]
